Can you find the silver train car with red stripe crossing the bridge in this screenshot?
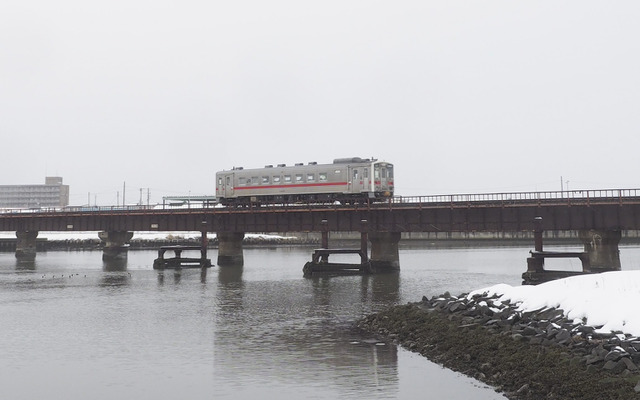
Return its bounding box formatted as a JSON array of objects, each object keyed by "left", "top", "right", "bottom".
[{"left": 216, "top": 157, "right": 393, "bottom": 205}]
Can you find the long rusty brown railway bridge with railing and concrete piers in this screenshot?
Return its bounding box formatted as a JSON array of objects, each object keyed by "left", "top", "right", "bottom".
[{"left": 0, "top": 189, "right": 640, "bottom": 276}]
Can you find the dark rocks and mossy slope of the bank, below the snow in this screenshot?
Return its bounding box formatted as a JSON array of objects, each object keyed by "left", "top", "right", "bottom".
[{"left": 357, "top": 293, "right": 640, "bottom": 400}]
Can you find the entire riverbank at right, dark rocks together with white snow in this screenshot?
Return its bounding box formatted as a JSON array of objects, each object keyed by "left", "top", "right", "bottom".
[{"left": 358, "top": 271, "right": 640, "bottom": 399}]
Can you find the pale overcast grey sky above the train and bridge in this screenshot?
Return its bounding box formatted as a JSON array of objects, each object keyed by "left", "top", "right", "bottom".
[{"left": 0, "top": 0, "right": 640, "bottom": 205}]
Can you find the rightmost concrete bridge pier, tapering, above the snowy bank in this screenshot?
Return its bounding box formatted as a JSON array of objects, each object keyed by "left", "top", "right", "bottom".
[{"left": 578, "top": 230, "right": 622, "bottom": 272}]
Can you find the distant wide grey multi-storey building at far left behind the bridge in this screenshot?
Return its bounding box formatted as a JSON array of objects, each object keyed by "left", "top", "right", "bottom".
[{"left": 0, "top": 176, "right": 69, "bottom": 208}]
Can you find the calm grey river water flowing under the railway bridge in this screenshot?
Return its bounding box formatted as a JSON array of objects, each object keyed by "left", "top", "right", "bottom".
[{"left": 0, "top": 246, "right": 640, "bottom": 400}]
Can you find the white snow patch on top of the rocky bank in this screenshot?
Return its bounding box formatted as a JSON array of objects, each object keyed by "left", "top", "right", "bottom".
[{"left": 469, "top": 271, "right": 640, "bottom": 336}]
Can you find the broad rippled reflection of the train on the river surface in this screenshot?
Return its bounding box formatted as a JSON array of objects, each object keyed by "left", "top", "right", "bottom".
[{"left": 214, "top": 268, "right": 399, "bottom": 398}]
